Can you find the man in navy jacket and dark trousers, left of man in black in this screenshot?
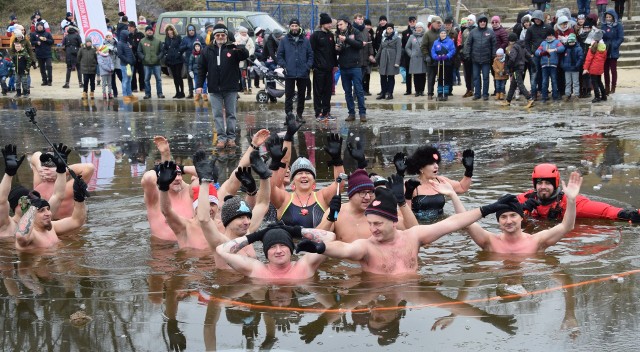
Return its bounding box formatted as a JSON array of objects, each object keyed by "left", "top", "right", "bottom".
[{"left": 277, "top": 18, "right": 313, "bottom": 121}]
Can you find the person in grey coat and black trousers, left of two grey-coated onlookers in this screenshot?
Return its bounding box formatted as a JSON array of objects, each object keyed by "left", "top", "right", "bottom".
[{"left": 376, "top": 23, "right": 402, "bottom": 100}]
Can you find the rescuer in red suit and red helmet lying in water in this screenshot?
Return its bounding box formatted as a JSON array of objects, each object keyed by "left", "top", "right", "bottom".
[{"left": 518, "top": 164, "right": 640, "bottom": 223}]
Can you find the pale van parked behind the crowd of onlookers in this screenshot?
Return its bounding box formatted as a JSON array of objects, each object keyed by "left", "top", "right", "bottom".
[{"left": 155, "top": 11, "right": 286, "bottom": 41}]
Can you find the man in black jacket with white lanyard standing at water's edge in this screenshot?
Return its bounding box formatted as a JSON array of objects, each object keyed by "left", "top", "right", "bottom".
[{"left": 196, "top": 23, "right": 248, "bottom": 149}]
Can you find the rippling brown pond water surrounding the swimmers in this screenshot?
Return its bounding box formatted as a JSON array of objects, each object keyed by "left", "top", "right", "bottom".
[{"left": 0, "top": 100, "right": 640, "bottom": 351}]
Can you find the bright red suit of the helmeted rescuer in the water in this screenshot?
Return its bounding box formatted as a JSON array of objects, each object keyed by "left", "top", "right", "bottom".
[{"left": 518, "top": 190, "right": 622, "bottom": 220}]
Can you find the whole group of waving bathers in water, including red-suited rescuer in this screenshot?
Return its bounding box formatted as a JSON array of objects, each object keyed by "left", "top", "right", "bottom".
[{"left": 0, "top": 115, "right": 640, "bottom": 280}]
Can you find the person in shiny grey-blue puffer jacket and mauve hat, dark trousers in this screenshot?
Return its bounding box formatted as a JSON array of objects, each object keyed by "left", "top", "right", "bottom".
[{"left": 464, "top": 15, "right": 496, "bottom": 100}]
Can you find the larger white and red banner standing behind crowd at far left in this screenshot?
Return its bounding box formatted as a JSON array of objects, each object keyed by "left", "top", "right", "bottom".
[{"left": 72, "top": 0, "right": 107, "bottom": 46}]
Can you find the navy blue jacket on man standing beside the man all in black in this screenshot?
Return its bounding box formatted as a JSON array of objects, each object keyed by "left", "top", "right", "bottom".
[{"left": 276, "top": 33, "right": 313, "bottom": 78}]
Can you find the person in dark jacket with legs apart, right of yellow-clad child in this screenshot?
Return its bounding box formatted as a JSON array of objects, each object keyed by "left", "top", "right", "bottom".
[{"left": 502, "top": 33, "right": 533, "bottom": 109}]
